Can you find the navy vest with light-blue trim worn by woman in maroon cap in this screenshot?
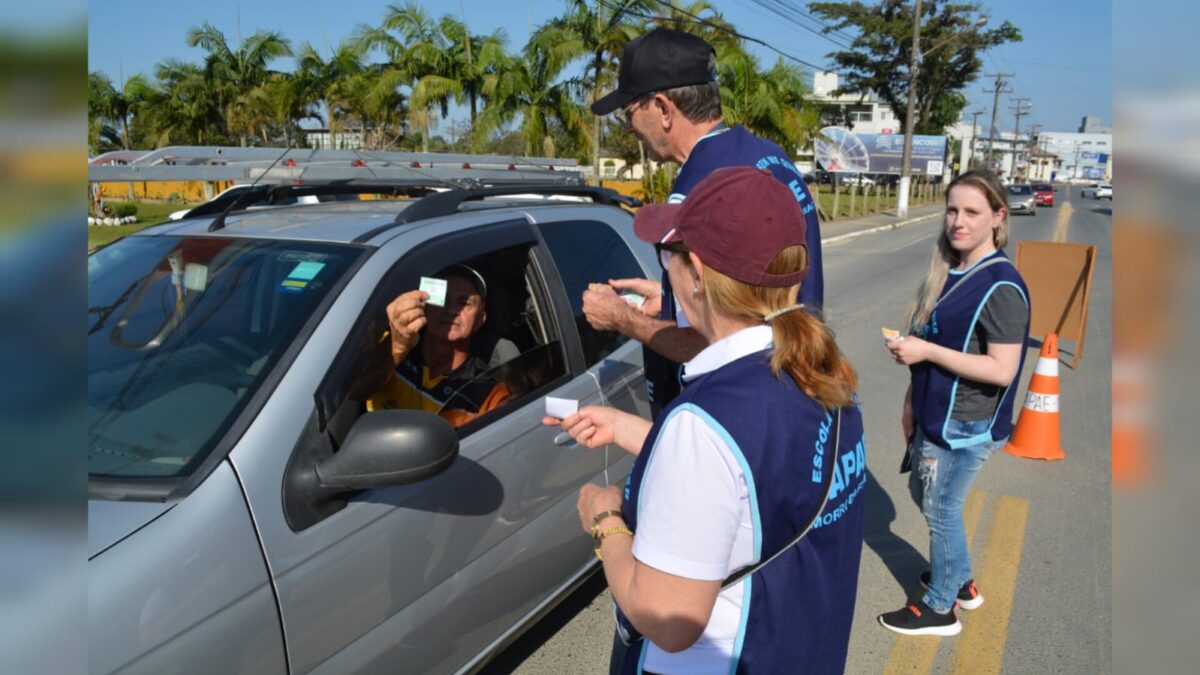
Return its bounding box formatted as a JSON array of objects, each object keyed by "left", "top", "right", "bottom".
[{"left": 618, "top": 351, "right": 866, "bottom": 674}]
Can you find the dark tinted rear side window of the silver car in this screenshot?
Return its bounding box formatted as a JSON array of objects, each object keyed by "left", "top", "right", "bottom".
[{"left": 541, "top": 221, "right": 646, "bottom": 368}]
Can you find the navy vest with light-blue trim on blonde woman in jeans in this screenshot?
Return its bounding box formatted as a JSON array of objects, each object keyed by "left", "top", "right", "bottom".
[{"left": 910, "top": 250, "right": 1030, "bottom": 449}]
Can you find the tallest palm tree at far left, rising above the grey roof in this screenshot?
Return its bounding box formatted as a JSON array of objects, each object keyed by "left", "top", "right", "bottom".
[{"left": 187, "top": 22, "right": 292, "bottom": 145}]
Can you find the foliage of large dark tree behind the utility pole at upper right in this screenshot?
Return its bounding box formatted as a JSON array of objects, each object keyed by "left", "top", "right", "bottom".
[{"left": 809, "top": 0, "right": 1021, "bottom": 135}]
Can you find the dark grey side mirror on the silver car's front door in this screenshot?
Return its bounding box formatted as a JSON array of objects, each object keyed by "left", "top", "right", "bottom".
[{"left": 314, "top": 411, "right": 458, "bottom": 490}]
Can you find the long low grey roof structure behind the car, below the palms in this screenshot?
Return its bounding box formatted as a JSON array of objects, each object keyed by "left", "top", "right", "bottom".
[{"left": 88, "top": 145, "right": 581, "bottom": 187}]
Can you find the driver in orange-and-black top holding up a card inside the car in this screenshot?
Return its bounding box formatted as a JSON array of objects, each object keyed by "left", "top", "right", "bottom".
[{"left": 367, "top": 264, "right": 511, "bottom": 428}]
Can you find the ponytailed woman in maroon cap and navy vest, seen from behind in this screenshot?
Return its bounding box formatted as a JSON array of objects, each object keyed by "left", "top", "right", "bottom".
[{"left": 546, "top": 167, "right": 866, "bottom": 673}]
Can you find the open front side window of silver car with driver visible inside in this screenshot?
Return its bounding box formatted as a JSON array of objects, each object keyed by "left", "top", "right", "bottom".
[{"left": 330, "top": 240, "right": 566, "bottom": 440}]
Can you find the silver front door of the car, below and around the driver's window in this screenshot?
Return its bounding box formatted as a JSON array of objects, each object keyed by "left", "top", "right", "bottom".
[{"left": 235, "top": 215, "right": 601, "bottom": 673}]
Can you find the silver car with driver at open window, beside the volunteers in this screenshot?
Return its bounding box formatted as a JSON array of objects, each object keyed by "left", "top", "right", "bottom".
[{"left": 88, "top": 184, "right": 658, "bottom": 673}]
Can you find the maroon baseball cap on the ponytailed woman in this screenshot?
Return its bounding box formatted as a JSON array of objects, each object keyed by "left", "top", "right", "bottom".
[{"left": 634, "top": 167, "right": 808, "bottom": 286}]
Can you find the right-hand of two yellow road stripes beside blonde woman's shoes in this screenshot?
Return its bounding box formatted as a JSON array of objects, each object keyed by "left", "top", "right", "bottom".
[{"left": 954, "top": 495, "right": 1030, "bottom": 675}]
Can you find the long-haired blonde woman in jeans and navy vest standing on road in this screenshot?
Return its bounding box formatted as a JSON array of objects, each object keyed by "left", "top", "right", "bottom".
[{"left": 880, "top": 171, "right": 1030, "bottom": 635}]
